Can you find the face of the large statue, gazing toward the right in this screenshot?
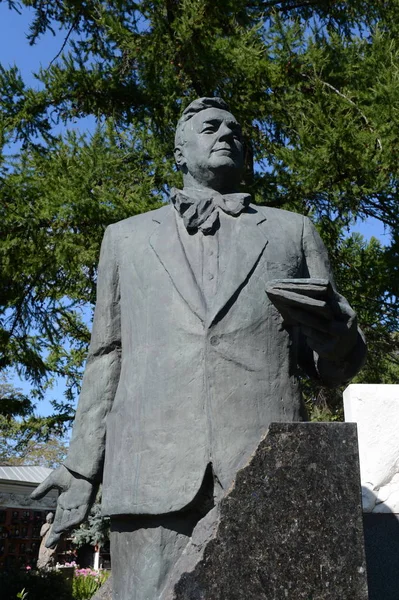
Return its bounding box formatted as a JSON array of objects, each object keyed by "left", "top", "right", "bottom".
[{"left": 181, "top": 108, "right": 244, "bottom": 189}]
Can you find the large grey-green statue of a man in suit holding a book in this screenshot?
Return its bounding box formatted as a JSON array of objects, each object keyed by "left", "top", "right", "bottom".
[{"left": 35, "top": 98, "right": 365, "bottom": 600}]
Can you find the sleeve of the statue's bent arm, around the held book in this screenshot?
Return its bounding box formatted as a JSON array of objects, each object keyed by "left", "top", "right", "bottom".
[{"left": 299, "top": 217, "right": 366, "bottom": 387}]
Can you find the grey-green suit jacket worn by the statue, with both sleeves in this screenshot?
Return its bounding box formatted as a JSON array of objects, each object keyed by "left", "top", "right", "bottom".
[{"left": 65, "top": 205, "right": 364, "bottom": 515}]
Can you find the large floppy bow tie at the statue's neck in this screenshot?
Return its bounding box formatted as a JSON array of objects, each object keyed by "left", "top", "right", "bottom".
[{"left": 170, "top": 188, "right": 251, "bottom": 235}]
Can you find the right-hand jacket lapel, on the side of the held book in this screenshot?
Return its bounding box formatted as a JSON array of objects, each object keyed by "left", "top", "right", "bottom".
[{"left": 206, "top": 205, "right": 268, "bottom": 327}]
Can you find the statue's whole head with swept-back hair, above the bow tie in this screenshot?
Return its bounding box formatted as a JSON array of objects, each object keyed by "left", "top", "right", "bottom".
[{"left": 175, "top": 98, "right": 244, "bottom": 192}]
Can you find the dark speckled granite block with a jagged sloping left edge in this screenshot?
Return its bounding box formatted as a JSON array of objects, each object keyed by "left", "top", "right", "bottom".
[{"left": 171, "top": 423, "right": 368, "bottom": 600}]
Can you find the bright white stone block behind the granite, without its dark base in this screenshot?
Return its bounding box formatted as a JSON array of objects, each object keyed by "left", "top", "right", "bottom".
[{"left": 344, "top": 384, "right": 399, "bottom": 515}]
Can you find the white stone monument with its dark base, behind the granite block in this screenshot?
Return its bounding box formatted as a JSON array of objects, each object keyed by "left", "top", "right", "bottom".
[{"left": 344, "top": 384, "right": 399, "bottom": 600}]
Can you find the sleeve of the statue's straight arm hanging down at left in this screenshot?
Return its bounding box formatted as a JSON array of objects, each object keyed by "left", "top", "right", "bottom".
[{"left": 64, "top": 225, "right": 121, "bottom": 482}]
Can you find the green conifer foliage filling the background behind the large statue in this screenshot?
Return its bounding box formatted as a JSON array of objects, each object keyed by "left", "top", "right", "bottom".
[{"left": 0, "top": 0, "right": 399, "bottom": 427}]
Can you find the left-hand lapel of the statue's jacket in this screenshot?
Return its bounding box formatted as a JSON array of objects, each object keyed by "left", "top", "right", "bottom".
[{"left": 150, "top": 207, "right": 206, "bottom": 322}]
